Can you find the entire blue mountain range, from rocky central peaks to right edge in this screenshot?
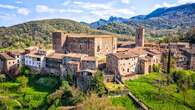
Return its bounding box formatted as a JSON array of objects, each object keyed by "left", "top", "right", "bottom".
[{"left": 90, "top": 3, "right": 195, "bottom": 34}]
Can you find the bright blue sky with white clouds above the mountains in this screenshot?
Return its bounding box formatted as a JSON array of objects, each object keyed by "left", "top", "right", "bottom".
[{"left": 0, "top": 0, "right": 195, "bottom": 26}]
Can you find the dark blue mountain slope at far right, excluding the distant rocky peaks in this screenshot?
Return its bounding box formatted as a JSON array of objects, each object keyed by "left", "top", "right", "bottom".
[{"left": 129, "top": 3, "right": 195, "bottom": 29}]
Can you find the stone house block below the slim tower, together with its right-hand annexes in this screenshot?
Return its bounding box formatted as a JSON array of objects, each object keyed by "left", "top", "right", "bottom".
[{"left": 107, "top": 48, "right": 161, "bottom": 80}]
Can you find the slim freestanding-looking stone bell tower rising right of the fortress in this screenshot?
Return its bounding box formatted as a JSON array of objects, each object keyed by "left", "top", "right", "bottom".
[{"left": 135, "top": 27, "right": 145, "bottom": 47}]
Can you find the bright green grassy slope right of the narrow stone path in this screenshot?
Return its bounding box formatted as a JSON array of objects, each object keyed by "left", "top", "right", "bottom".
[{"left": 126, "top": 73, "right": 195, "bottom": 110}]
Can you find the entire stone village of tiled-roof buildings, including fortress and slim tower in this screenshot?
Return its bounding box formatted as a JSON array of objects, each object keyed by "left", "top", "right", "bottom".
[{"left": 0, "top": 27, "right": 195, "bottom": 88}]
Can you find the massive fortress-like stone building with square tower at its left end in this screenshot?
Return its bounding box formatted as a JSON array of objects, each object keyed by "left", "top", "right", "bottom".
[{"left": 52, "top": 32, "right": 117, "bottom": 56}]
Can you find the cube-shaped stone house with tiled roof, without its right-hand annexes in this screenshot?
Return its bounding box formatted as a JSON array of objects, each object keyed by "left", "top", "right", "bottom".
[{"left": 107, "top": 47, "right": 144, "bottom": 79}]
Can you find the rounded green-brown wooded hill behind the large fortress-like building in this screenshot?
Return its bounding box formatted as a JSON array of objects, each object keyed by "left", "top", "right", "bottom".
[{"left": 0, "top": 19, "right": 108, "bottom": 48}]
